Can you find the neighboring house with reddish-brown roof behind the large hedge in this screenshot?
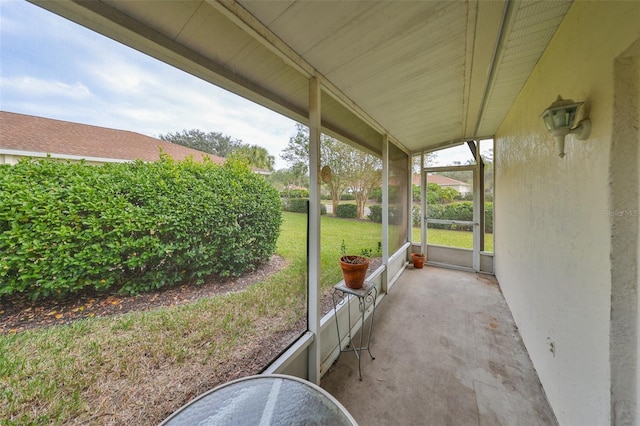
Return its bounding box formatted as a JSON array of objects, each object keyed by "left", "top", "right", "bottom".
[{"left": 0, "top": 111, "right": 225, "bottom": 164}]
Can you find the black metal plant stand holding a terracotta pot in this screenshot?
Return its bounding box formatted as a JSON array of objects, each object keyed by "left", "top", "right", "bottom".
[{"left": 332, "top": 281, "right": 378, "bottom": 381}]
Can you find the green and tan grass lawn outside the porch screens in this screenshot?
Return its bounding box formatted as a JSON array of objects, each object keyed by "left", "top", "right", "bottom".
[{"left": 0, "top": 213, "right": 484, "bottom": 425}]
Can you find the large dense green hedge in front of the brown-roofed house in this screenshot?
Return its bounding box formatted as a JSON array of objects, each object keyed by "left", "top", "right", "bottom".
[{"left": 0, "top": 156, "right": 282, "bottom": 299}]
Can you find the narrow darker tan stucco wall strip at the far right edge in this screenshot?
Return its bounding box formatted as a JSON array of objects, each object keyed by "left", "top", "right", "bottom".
[{"left": 609, "top": 38, "right": 640, "bottom": 425}]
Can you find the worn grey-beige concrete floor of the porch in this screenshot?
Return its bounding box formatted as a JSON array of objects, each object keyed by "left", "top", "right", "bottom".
[{"left": 321, "top": 267, "right": 557, "bottom": 426}]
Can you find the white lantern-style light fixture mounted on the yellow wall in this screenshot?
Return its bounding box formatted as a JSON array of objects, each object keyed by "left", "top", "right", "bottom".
[{"left": 541, "top": 95, "right": 591, "bottom": 158}]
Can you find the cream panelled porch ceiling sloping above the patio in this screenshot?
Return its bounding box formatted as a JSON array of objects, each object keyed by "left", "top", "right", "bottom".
[{"left": 34, "top": 0, "right": 571, "bottom": 153}]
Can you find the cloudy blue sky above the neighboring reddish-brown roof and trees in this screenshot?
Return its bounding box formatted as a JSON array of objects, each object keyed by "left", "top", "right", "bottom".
[{"left": 0, "top": 0, "right": 296, "bottom": 169}]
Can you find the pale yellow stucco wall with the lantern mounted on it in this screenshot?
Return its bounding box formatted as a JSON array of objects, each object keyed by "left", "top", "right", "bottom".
[{"left": 494, "top": 1, "right": 640, "bottom": 425}]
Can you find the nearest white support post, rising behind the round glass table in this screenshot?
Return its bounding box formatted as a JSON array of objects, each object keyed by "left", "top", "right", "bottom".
[{"left": 307, "top": 77, "right": 322, "bottom": 385}]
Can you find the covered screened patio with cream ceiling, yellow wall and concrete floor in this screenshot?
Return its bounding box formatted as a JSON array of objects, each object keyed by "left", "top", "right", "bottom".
[{"left": 32, "top": 0, "right": 640, "bottom": 425}]
